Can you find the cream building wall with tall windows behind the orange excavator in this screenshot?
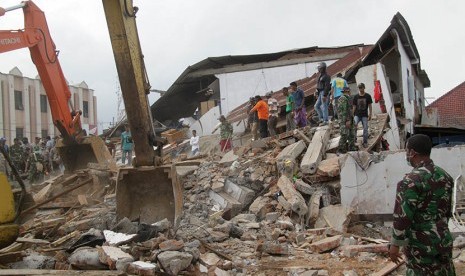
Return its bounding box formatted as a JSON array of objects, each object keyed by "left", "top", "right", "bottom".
[{"left": 0, "top": 67, "right": 97, "bottom": 144}]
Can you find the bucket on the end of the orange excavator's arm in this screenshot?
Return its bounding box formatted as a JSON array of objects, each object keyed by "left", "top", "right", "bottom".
[{"left": 57, "top": 136, "right": 116, "bottom": 174}]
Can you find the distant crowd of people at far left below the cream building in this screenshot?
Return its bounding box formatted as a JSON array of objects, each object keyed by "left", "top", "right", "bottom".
[{"left": 0, "top": 136, "right": 64, "bottom": 183}]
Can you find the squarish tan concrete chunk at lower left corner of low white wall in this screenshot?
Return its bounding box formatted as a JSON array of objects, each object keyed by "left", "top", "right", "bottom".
[{"left": 315, "top": 205, "right": 353, "bottom": 233}]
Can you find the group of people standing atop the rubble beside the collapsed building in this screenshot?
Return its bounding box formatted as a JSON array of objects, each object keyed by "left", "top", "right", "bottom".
[{"left": 212, "top": 62, "right": 373, "bottom": 153}]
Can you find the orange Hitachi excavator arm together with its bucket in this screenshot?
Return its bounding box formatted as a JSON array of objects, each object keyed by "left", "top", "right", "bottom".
[{"left": 0, "top": 1, "right": 113, "bottom": 173}]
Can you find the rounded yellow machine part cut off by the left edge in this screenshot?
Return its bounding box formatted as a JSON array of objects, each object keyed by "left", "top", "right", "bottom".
[{"left": 0, "top": 173, "right": 19, "bottom": 248}]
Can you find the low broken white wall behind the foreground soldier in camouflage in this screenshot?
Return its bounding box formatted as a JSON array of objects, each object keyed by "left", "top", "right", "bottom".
[{"left": 341, "top": 146, "right": 465, "bottom": 214}]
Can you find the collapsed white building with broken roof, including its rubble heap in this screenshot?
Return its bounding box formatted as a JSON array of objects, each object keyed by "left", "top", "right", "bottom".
[{"left": 0, "top": 14, "right": 465, "bottom": 275}]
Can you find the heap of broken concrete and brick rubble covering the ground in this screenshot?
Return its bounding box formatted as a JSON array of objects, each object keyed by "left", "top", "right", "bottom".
[{"left": 0, "top": 115, "right": 465, "bottom": 275}]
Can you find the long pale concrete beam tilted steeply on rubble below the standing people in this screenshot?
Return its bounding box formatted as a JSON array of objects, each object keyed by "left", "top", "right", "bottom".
[{"left": 300, "top": 124, "right": 331, "bottom": 174}]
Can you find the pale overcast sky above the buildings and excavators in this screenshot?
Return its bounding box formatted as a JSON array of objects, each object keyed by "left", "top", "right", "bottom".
[{"left": 0, "top": 0, "right": 465, "bottom": 131}]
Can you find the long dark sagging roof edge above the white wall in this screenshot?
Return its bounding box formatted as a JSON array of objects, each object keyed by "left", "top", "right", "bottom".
[{"left": 151, "top": 45, "right": 363, "bottom": 122}]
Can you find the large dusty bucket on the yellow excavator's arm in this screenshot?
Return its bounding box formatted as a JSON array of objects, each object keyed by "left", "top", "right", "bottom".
[{"left": 116, "top": 166, "right": 183, "bottom": 226}]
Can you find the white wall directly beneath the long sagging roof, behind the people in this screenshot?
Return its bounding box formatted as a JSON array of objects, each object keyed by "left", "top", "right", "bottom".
[{"left": 216, "top": 60, "right": 335, "bottom": 115}]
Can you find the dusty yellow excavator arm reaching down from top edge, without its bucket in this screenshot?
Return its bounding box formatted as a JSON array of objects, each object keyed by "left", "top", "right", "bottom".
[{"left": 103, "top": 0, "right": 156, "bottom": 166}]
